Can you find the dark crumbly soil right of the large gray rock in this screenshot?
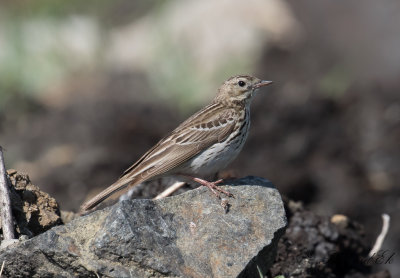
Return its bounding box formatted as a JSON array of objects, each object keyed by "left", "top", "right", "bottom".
[{"left": 269, "top": 200, "right": 395, "bottom": 278}]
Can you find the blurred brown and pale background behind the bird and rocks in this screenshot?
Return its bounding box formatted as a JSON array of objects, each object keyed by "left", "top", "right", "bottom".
[{"left": 0, "top": 0, "right": 400, "bottom": 277}]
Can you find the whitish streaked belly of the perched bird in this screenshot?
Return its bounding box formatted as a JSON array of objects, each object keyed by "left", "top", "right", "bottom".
[{"left": 182, "top": 128, "right": 247, "bottom": 176}]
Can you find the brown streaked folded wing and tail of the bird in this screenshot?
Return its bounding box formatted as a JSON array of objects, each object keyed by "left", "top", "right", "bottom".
[{"left": 81, "top": 103, "right": 238, "bottom": 212}]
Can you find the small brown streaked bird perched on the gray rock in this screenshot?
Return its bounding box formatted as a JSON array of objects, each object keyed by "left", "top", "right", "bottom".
[{"left": 81, "top": 75, "right": 272, "bottom": 213}]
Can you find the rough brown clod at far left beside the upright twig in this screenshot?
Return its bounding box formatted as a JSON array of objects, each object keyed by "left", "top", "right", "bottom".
[{"left": 0, "top": 169, "right": 62, "bottom": 237}]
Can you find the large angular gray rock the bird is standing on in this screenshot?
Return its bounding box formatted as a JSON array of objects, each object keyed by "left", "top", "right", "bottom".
[{"left": 0, "top": 177, "right": 286, "bottom": 277}]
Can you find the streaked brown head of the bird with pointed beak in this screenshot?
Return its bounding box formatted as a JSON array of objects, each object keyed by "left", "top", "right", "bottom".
[{"left": 215, "top": 75, "right": 272, "bottom": 102}]
